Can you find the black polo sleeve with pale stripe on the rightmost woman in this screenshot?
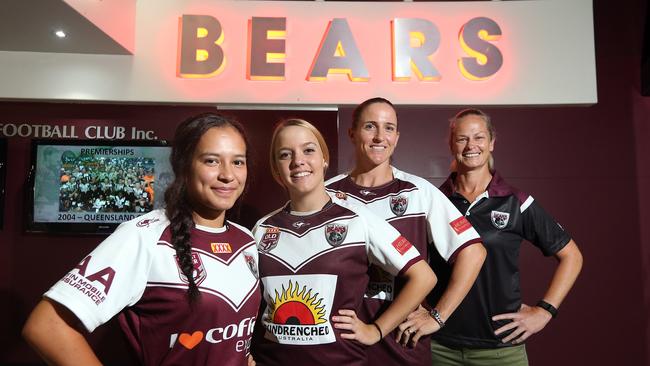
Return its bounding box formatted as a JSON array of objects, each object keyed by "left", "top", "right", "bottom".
[{"left": 520, "top": 196, "right": 571, "bottom": 256}]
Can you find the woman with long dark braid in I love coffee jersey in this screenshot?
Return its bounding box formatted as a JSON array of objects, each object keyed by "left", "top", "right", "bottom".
[{"left": 23, "top": 114, "right": 260, "bottom": 366}]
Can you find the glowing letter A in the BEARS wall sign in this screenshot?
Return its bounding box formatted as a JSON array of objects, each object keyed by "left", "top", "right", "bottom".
[{"left": 307, "top": 18, "right": 370, "bottom": 81}]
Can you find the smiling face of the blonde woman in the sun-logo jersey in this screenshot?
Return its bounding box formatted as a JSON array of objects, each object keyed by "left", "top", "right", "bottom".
[{"left": 273, "top": 125, "right": 327, "bottom": 201}]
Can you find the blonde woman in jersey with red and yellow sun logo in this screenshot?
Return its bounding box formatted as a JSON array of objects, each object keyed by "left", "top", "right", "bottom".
[{"left": 253, "top": 119, "right": 435, "bottom": 366}]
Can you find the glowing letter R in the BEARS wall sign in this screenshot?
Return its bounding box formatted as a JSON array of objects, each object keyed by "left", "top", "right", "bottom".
[{"left": 391, "top": 18, "right": 440, "bottom": 81}]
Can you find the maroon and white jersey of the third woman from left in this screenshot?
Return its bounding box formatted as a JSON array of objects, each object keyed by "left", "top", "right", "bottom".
[{"left": 325, "top": 167, "right": 480, "bottom": 366}]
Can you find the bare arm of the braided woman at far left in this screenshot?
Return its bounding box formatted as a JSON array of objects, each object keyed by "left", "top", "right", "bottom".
[{"left": 23, "top": 298, "right": 101, "bottom": 365}]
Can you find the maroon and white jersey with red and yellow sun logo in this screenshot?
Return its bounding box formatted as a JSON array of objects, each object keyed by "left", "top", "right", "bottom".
[{"left": 253, "top": 200, "right": 422, "bottom": 366}]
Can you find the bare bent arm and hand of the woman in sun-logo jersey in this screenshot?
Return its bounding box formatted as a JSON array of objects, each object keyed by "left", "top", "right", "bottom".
[{"left": 332, "top": 260, "right": 437, "bottom": 345}]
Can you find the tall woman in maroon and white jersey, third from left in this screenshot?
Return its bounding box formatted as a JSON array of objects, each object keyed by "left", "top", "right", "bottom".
[{"left": 326, "top": 97, "right": 485, "bottom": 366}]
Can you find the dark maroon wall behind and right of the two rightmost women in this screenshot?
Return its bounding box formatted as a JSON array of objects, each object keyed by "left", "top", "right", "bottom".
[{"left": 339, "top": 1, "right": 650, "bottom": 365}]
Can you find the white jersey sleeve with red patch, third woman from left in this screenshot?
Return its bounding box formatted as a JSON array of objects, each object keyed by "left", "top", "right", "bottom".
[{"left": 422, "top": 184, "right": 481, "bottom": 261}]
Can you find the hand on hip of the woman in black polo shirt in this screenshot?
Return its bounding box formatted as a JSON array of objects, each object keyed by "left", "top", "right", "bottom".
[{"left": 492, "top": 304, "right": 552, "bottom": 344}]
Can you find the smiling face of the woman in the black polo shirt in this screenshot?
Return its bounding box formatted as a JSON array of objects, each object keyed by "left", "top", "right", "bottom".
[{"left": 450, "top": 114, "right": 494, "bottom": 172}]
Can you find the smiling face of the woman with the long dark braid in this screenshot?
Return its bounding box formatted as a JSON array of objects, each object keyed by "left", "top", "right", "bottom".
[{"left": 187, "top": 126, "right": 248, "bottom": 226}]
